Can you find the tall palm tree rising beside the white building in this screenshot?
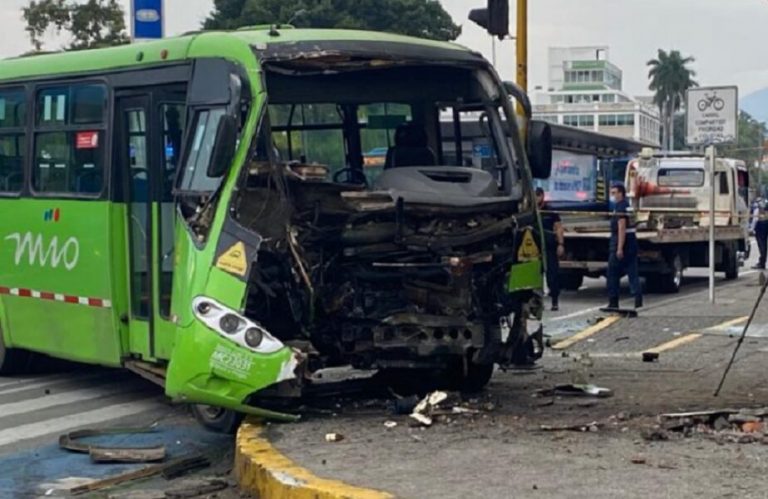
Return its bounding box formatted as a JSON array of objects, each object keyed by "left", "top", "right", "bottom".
[{"left": 648, "top": 49, "right": 699, "bottom": 150}]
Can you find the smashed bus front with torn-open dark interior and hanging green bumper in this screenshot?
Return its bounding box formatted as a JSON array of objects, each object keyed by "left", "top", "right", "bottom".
[{"left": 167, "top": 30, "right": 551, "bottom": 426}]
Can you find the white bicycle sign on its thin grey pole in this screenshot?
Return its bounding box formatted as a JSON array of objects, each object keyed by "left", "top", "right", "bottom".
[{"left": 685, "top": 87, "right": 739, "bottom": 303}]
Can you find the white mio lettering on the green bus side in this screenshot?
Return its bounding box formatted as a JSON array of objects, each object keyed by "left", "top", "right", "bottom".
[{"left": 5, "top": 232, "right": 80, "bottom": 270}]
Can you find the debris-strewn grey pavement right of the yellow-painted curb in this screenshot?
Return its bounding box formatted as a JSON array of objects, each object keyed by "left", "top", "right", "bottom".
[{"left": 268, "top": 248, "right": 768, "bottom": 499}]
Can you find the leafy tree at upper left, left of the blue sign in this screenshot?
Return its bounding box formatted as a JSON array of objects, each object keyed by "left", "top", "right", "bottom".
[{"left": 22, "top": 0, "right": 130, "bottom": 52}]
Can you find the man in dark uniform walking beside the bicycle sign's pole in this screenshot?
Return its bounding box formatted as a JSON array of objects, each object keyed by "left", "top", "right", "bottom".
[{"left": 608, "top": 183, "right": 643, "bottom": 309}]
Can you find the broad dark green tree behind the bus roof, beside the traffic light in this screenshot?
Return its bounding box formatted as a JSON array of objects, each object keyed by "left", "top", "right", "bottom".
[{"left": 204, "top": 0, "right": 461, "bottom": 40}]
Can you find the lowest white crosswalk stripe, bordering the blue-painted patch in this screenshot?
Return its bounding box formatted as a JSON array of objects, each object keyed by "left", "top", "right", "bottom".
[{"left": 0, "top": 398, "right": 160, "bottom": 446}]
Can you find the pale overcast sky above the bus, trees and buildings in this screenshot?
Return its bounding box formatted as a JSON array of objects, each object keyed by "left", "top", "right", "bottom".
[{"left": 0, "top": 0, "right": 768, "bottom": 96}]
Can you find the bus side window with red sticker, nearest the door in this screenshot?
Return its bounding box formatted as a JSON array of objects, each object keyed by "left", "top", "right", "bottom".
[{"left": 32, "top": 84, "right": 107, "bottom": 197}]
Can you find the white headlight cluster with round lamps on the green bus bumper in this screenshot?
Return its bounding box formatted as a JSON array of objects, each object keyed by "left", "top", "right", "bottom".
[{"left": 192, "top": 296, "right": 285, "bottom": 353}]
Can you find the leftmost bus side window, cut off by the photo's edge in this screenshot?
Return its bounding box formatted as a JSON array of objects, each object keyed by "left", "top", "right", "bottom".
[{"left": 0, "top": 90, "right": 27, "bottom": 193}]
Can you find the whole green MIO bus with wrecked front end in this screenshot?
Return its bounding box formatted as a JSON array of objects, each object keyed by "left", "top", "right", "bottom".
[{"left": 0, "top": 26, "right": 551, "bottom": 427}]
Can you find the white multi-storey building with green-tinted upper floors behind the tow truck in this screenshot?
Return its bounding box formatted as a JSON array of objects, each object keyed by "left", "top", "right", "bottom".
[{"left": 533, "top": 47, "right": 661, "bottom": 147}]
